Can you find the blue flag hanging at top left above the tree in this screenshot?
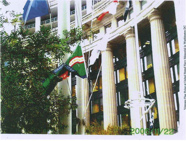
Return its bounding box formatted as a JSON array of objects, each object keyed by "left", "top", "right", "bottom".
[{"left": 23, "top": 0, "right": 49, "bottom": 23}]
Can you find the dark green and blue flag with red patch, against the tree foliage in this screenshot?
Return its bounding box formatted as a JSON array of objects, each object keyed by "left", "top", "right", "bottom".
[{"left": 43, "top": 63, "right": 77, "bottom": 94}]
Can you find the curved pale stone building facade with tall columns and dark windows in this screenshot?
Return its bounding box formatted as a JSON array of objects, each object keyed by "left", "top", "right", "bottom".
[{"left": 26, "top": 0, "right": 181, "bottom": 134}]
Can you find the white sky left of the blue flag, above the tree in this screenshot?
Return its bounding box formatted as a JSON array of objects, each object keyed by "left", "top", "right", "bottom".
[{"left": 1, "top": 0, "right": 27, "bottom": 33}]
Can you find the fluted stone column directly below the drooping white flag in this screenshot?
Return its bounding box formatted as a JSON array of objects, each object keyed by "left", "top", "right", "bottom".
[{"left": 101, "top": 47, "right": 118, "bottom": 130}]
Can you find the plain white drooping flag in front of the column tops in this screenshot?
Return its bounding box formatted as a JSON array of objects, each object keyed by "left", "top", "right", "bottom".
[{"left": 89, "top": 34, "right": 109, "bottom": 65}]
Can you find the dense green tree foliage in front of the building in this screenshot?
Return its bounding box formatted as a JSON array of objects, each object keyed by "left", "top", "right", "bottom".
[{"left": 1, "top": 27, "right": 77, "bottom": 134}]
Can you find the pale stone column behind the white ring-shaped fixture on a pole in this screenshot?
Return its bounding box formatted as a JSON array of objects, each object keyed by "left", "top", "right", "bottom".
[{"left": 124, "top": 28, "right": 141, "bottom": 129}]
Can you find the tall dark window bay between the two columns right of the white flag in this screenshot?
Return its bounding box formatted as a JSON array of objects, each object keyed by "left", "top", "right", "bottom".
[{"left": 113, "top": 43, "right": 130, "bottom": 126}]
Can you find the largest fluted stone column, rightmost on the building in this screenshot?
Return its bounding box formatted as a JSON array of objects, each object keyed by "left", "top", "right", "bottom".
[{"left": 148, "top": 9, "right": 177, "bottom": 129}]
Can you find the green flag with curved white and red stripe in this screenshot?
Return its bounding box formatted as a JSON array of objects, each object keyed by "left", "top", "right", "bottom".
[{"left": 65, "top": 43, "right": 86, "bottom": 78}]
